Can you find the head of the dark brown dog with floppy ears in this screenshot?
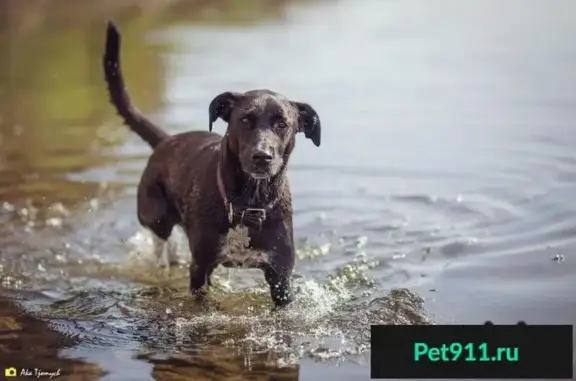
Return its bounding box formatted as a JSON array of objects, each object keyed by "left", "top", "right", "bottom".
[{"left": 209, "top": 90, "right": 320, "bottom": 179}]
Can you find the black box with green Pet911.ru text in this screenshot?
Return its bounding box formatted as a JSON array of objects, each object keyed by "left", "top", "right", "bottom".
[{"left": 370, "top": 322, "right": 574, "bottom": 379}]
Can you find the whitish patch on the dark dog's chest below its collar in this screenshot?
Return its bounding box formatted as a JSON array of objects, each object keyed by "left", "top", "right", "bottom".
[{"left": 218, "top": 226, "right": 268, "bottom": 268}]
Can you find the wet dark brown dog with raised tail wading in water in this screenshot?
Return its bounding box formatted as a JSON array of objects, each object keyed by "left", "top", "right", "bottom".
[{"left": 103, "top": 22, "right": 320, "bottom": 306}]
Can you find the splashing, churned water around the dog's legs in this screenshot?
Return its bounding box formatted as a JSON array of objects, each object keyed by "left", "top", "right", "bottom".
[{"left": 13, "top": 224, "right": 429, "bottom": 367}]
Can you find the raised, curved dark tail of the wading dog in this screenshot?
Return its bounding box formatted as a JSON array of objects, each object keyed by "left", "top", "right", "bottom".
[{"left": 103, "top": 21, "right": 169, "bottom": 148}]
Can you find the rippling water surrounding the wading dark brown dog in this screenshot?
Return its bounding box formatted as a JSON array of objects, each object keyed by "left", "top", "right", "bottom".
[{"left": 0, "top": 0, "right": 576, "bottom": 380}]
